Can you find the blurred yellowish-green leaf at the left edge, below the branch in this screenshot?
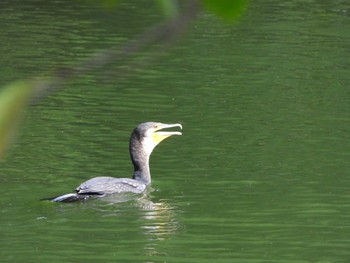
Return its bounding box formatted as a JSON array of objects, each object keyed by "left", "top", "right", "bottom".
[{"left": 0, "top": 81, "right": 33, "bottom": 158}]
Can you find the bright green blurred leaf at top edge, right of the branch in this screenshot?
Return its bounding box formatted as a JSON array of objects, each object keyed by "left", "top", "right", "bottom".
[{"left": 203, "top": 0, "right": 249, "bottom": 21}]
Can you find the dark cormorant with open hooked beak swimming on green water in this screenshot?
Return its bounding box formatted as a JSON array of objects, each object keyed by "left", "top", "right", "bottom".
[{"left": 46, "top": 122, "right": 182, "bottom": 202}]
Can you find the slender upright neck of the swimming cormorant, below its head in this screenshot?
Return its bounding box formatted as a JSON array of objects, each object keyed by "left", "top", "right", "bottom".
[{"left": 129, "top": 134, "right": 151, "bottom": 185}]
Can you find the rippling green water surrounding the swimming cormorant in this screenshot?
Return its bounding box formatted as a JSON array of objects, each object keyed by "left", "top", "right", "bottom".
[{"left": 0, "top": 0, "right": 350, "bottom": 263}]
